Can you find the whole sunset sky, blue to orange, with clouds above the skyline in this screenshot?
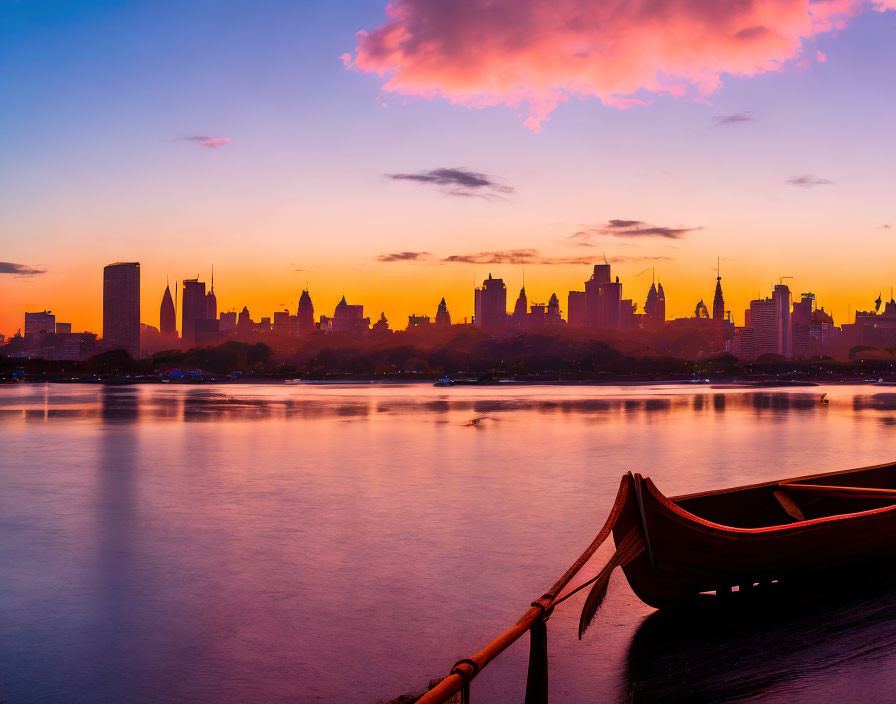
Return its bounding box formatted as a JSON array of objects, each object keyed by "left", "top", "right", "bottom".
[{"left": 0, "top": 0, "right": 896, "bottom": 335}]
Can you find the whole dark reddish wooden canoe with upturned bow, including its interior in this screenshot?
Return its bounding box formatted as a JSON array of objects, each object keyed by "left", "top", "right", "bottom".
[{"left": 607, "top": 463, "right": 896, "bottom": 608}]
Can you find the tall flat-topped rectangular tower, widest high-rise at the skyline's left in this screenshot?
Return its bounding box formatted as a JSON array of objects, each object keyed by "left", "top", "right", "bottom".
[{"left": 103, "top": 262, "right": 140, "bottom": 357}]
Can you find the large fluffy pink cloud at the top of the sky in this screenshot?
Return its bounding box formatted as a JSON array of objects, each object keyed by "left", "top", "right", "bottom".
[{"left": 347, "top": 0, "right": 880, "bottom": 132}]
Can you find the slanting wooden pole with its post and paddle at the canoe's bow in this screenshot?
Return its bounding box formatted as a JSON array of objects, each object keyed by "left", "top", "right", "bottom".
[{"left": 417, "top": 473, "right": 644, "bottom": 704}]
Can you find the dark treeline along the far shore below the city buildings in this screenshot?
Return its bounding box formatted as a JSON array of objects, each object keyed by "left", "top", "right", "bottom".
[{"left": 0, "top": 326, "right": 894, "bottom": 380}]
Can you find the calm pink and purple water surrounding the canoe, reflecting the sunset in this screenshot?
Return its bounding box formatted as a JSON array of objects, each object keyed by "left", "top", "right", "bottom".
[{"left": 0, "top": 385, "right": 896, "bottom": 703}]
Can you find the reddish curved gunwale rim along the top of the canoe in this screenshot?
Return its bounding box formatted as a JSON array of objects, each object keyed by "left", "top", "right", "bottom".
[{"left": 644, "top": 462, "right": 896, "bottom": 538}]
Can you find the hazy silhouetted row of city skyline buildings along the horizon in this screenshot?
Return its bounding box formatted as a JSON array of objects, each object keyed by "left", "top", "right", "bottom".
[{"left": 19, "top": 262, "right": 896, "bottom": 361}]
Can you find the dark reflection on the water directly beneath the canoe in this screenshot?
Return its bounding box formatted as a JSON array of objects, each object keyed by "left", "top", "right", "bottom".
[{"left": 622, "top": 576, "right": 896, "bottom": 704}]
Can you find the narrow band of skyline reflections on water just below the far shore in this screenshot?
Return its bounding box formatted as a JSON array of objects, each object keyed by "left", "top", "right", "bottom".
[{"left": 0, "top": 385, "right": 880, "bottom": 423}]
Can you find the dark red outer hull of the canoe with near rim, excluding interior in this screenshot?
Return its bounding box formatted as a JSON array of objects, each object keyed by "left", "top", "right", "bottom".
[{"left": 613, "top": 464, "right": 896, "bottom": 608}]
